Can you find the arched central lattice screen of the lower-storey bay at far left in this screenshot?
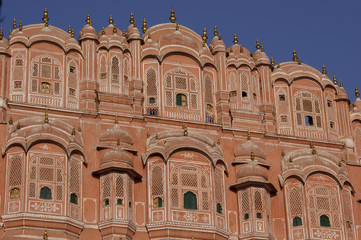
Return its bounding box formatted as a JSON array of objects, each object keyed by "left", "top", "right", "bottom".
[{"left": 28, "top": 154, "right": 65, "bottom": 201}]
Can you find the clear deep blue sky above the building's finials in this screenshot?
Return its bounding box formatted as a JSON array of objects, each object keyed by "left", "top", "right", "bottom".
[{"left": 0, "top": 0, "right": 361, "bottom": 101}]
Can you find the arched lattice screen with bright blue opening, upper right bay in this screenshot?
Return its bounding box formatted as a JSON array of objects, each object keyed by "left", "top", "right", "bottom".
[{"left": 295, "top": 91, "right": 322, "bottom": 128}]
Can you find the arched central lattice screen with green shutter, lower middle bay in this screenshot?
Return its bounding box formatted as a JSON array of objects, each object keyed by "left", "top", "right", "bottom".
[{"left": 170, "top": 164, "right": 210, "bottom": 211}]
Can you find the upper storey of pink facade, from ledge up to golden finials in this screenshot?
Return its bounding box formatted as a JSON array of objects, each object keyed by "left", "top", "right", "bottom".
[{"left": 0, "top": 10, "right": 361, "bottom": 155}]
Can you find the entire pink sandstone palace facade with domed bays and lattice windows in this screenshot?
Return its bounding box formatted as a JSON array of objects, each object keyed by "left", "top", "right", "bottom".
[{"left": 0, "top": 8, "right": 361, "bottom": 240}]
